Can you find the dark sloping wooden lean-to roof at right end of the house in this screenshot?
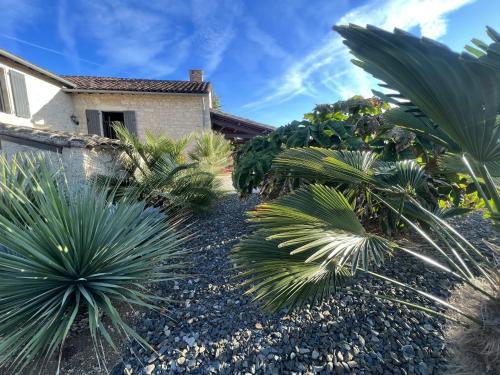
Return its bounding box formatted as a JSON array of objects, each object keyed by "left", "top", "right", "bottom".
[{"left": 210, "top": 109, "right": 275, "bottom": 143}]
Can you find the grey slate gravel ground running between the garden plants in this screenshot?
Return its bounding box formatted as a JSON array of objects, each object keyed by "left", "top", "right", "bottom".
[{"left": 113, "top": 195, "right": 493, "bottom": 375}]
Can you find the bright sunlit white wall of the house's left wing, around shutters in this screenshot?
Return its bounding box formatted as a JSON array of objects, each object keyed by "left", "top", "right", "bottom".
[{"left": 0, "top": 57, "right": 80, "bottom": 132}]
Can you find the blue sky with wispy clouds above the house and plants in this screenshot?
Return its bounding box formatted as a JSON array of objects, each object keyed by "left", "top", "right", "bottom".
[{"left": 0, "top": 0, "right": 500, "bottom": 126}]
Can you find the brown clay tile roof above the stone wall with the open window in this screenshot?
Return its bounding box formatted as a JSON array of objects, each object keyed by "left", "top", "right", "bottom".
[{"left": 62, "top": 76, "right": 210, "bottom": 94}]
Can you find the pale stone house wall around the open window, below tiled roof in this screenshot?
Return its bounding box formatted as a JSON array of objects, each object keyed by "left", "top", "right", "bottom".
[{"left": 73, "top": 93, "right": 210, "bottom": 139}]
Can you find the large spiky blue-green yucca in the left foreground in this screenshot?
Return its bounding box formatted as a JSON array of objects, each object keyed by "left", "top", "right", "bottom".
[{"left": 0, "top": 156, "right": 181, "bottom": 373}]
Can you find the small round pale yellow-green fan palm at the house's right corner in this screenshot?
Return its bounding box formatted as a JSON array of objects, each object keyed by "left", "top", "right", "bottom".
[{"left": 189, "top": 130, "right": 233, "bottom": 174}]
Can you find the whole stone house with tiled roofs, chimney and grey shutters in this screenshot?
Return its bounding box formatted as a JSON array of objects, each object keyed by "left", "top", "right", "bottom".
[{"left": 0, "top": 49, "right": 273, "bottom": 185}]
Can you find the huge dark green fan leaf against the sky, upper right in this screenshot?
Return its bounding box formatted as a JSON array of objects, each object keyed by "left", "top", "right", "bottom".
[{"left": 335, "top": 25, "right": 500, "bottom": 162}]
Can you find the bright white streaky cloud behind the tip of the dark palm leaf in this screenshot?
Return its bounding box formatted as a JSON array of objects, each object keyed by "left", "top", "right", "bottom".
[{"left": 244, "top": 0, "right": 475, "bottom": 109}]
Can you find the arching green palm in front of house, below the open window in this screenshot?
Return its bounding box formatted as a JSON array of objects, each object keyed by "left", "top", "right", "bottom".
[{"left": 115, "top": 128, "right": 221, "bottom": 213}]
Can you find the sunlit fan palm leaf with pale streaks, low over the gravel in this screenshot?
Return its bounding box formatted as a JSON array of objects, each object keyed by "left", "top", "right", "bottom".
[{"left": 231, "top": 185, "right": 394, "bottom": 310}]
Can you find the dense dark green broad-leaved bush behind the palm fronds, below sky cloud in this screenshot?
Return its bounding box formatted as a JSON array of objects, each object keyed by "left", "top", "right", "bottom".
[{"left": 233, "top": 96, "right": 396, "bottom": 197}]
